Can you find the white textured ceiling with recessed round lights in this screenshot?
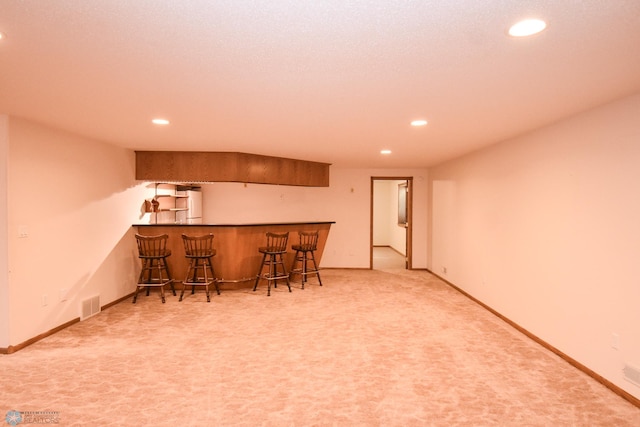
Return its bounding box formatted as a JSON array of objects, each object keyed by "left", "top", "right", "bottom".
[{"left": 0, "top": 0, "right": 640, "bottom": 168}]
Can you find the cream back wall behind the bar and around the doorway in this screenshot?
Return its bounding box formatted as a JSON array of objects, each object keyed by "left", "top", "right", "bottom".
[{"left": 202, "top": 166, "right": 428, "bottom": 268}]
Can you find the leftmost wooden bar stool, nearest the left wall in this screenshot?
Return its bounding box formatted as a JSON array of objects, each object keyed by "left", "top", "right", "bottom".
[{"left": 133, "top": 234, "right": 176, "bottom": 304}]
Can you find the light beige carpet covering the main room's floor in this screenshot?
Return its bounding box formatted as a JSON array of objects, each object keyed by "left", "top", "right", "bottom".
[{"left": 0, "top": 270, "right": 640, "bottom": 426}]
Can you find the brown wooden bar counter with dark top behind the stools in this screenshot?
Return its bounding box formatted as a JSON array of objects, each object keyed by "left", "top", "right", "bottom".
[{"left": 134, "top": 221, "right": 335, "bottom": 289}]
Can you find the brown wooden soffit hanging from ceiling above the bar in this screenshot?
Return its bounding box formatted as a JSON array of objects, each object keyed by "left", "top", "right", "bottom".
[{"left": 136, "top": 151, "right": 330, "bottom": 187}]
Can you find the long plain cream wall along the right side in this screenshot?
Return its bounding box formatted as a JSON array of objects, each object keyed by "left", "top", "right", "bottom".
[{"left": 429, "top": 94, "right": 640, "bottom": 397}]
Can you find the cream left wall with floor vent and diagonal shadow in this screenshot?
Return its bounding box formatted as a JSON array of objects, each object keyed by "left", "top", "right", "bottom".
[{"left": 5, "top": 117, "right": 145, "bottom": 347}]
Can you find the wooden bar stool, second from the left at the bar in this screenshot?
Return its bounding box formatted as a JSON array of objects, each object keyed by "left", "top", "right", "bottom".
[{"left": 179, "top": 233, "right": 220, "bottom": 302}]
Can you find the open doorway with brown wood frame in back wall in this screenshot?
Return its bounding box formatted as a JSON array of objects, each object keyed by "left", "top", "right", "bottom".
[{"left": 369, "top": 177, "right": 413, "bottom": 270}]
